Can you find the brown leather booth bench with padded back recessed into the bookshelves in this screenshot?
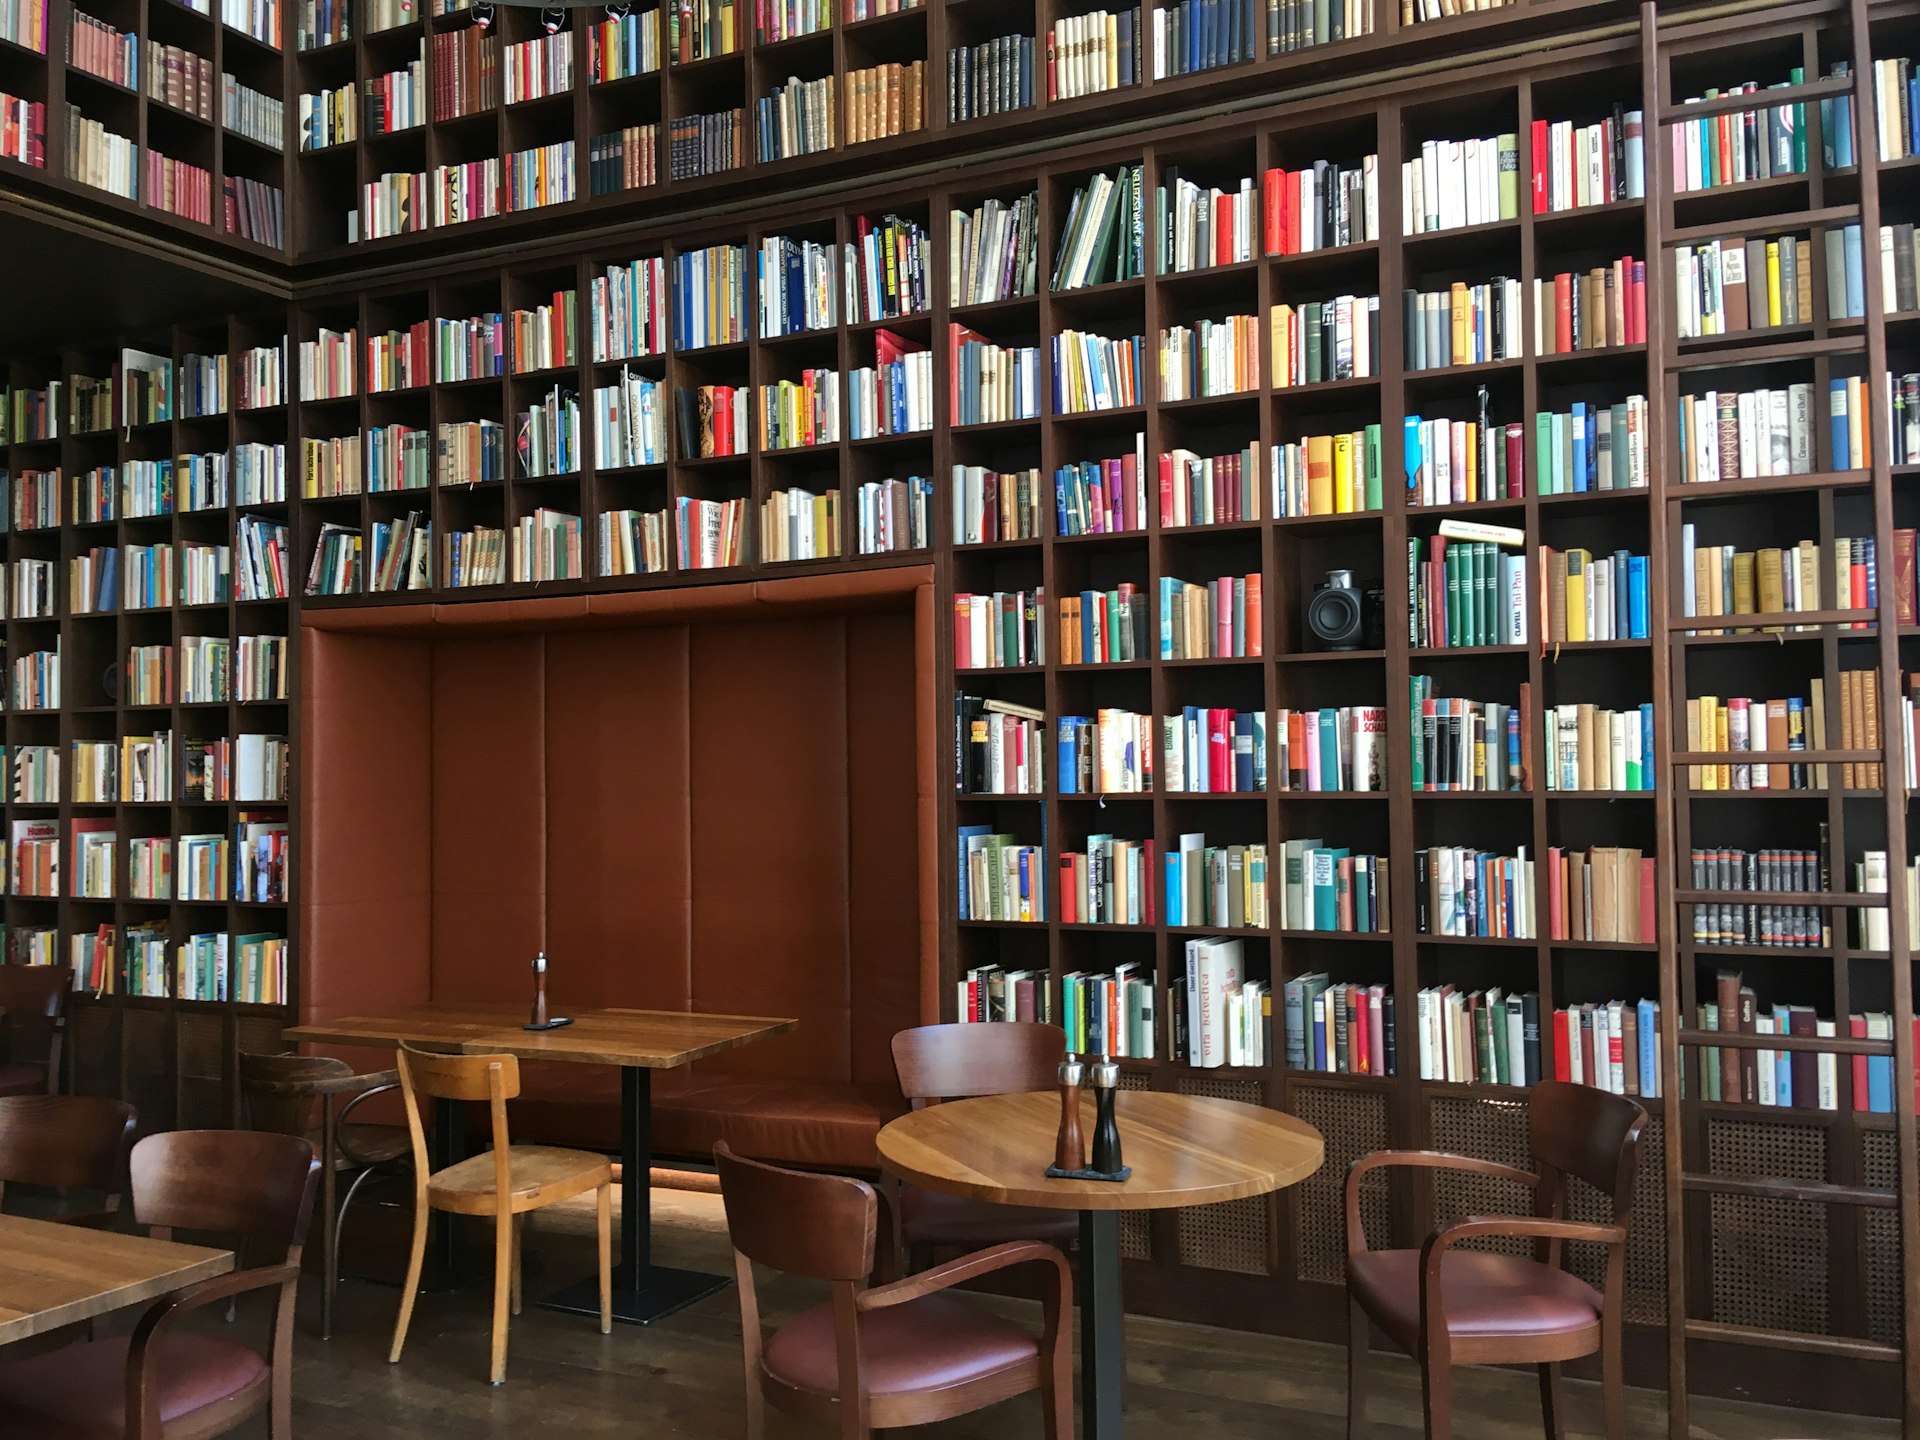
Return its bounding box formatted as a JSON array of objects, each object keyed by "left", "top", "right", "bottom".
[{"left": 296, "top": 566, "right": 939, "bottom": 1171}]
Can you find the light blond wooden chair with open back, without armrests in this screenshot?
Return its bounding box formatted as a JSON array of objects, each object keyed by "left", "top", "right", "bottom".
[{"left": 388, "top": 1044, "right": 612, "bottom": 1384}]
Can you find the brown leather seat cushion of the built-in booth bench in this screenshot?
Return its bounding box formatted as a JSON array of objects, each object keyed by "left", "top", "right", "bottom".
[{"left": 506, "top": 1064, "right": 906, "bottom": 1171}]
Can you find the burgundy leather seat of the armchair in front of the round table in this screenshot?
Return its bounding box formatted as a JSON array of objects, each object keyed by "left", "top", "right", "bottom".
[{"left": 760, "top": 1294, "right": 1041, "bottom": 1396}]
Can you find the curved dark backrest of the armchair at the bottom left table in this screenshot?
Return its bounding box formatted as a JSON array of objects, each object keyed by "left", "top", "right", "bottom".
[{"left": 131, "top": 1131, "right": 321, "bottom": 1265}]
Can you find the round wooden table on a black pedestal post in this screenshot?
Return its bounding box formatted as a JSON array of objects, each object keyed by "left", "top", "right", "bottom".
[{"left": 879, "top": 1091, "right": 1325, "bottom": 1440}]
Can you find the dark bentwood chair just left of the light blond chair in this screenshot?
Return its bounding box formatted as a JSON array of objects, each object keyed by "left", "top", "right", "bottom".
[{"left": 240, "top": 1050, "right": 409, "bottom": 1340}]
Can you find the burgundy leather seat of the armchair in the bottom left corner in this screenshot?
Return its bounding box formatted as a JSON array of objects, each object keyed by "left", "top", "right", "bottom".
[{"left": 0, "top": 1331, "right": 269, "bottom": 1440}]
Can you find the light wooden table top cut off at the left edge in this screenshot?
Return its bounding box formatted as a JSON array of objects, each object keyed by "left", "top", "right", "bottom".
[{"left": 0, "top": 1215, "right": 234, "bottom": 1346}]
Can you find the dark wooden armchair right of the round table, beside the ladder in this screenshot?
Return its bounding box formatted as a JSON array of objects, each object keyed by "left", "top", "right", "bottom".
[{"left": 1346, "top": 1081, "right": 1647, "bottom": 1440}]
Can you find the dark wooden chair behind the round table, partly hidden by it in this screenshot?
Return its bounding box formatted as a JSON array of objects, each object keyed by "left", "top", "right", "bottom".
[{"left": 889, "top": 1021, "right": 1079, "bottom": 1269}]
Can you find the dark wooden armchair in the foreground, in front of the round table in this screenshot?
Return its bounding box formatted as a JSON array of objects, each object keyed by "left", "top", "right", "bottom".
[{"left": 714, "top": 1142, "right": 1073, "bottom": 1440}]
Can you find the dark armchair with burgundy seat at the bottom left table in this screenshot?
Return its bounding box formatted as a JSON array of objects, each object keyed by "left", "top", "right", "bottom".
[{"left": 0, "top": 1131, "right": 321, "bottom": 1440}]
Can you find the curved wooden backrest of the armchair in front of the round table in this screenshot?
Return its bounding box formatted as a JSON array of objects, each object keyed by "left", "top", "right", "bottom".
[{"left": 714, "top": 1140, "right": 879, "bottom": 1284}]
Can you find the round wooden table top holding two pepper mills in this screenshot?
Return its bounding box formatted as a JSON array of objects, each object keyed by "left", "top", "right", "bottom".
[{"left": 879, "top": 1091, "right": 1325, "bottom": 1210}]
